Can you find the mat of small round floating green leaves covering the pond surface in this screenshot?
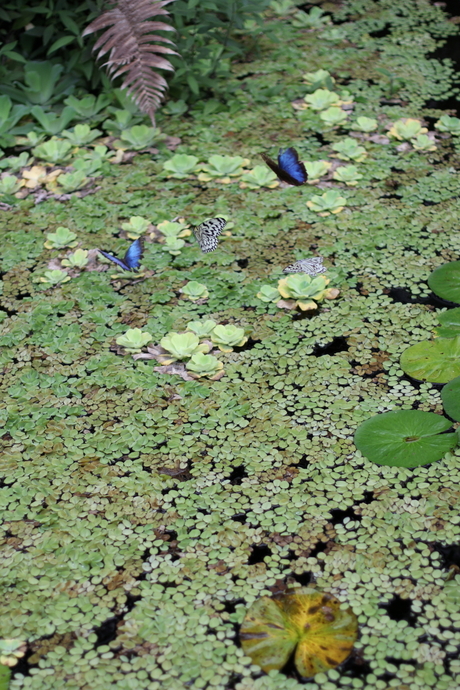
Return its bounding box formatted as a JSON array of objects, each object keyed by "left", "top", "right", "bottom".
[{"left": 0, "top": 0, "right": 460, "bottom": 690}]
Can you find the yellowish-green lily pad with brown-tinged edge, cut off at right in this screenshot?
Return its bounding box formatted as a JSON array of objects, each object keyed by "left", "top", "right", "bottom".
[{"left": 399, "top": 335, "right": 460, "bottom": 383}]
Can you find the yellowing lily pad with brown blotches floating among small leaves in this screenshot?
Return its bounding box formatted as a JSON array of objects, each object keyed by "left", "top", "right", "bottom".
[{"left": 240, "top": 587, "right": 358, "bottom": 678}]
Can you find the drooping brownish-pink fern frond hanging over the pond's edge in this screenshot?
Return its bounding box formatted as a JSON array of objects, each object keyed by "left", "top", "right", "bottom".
[{"left": 82, "top": 0, "right": 178, "bottom": 126}]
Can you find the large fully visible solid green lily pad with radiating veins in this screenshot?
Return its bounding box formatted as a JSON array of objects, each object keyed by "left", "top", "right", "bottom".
[{"left": 354, "top": 410, "right": 458, "bottom": 467}]
